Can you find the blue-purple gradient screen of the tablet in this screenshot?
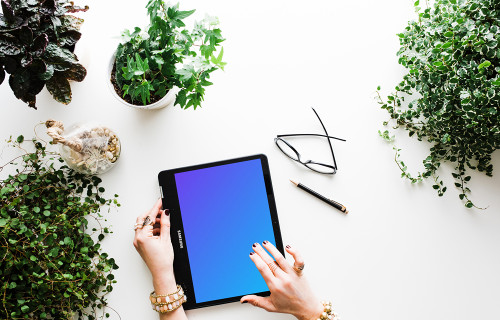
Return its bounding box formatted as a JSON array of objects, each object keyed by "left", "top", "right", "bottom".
[{"left": 175, "top": 159, "right": 275, "bottom": 303}]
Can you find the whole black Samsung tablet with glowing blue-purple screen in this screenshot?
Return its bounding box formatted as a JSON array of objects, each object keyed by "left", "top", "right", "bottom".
[{"left": 158, "top": 155, "right": 284, "bottom": 310}]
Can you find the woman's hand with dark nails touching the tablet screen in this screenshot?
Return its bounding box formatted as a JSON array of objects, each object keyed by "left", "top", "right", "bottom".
[{"left": 240, "top": 241, "right": 323, "bottom": 320}]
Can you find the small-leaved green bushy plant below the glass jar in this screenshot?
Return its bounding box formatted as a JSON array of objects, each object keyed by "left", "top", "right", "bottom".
[{"left": 0, "top": 136, "right": 119, "bottom": 320}]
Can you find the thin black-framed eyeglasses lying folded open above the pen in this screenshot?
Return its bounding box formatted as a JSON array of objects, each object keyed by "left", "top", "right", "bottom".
[{"left": 274, "top": 108, "right": 345, "bottom": 174}]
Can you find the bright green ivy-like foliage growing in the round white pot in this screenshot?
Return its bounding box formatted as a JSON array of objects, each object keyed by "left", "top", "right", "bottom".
[{"left": 111, "top": 0, "right": 226, "bottom": 109}]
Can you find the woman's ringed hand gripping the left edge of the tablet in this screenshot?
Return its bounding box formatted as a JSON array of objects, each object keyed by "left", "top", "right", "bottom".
[{"left": 134, "top": 199, "right": 177, "bottom": 294}]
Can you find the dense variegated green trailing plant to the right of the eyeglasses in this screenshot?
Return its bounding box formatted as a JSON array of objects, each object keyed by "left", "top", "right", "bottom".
[{"left": 377, "top": 0, "right": 500, "bottom": 208}]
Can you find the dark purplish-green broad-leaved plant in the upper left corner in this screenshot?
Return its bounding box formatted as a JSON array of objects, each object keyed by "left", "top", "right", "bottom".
[{"left": 0, "top": 0, "right": 88, "bottom": 109}]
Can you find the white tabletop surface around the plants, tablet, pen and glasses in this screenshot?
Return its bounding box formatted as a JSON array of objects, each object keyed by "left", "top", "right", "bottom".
[{"left": 0, "top": 0, "right": 500, "bottom": 320}]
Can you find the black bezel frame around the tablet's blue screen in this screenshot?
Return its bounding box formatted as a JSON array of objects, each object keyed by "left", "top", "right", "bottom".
[{"left": 158, "top": 154, "right": 284, "bottom": 310}]
